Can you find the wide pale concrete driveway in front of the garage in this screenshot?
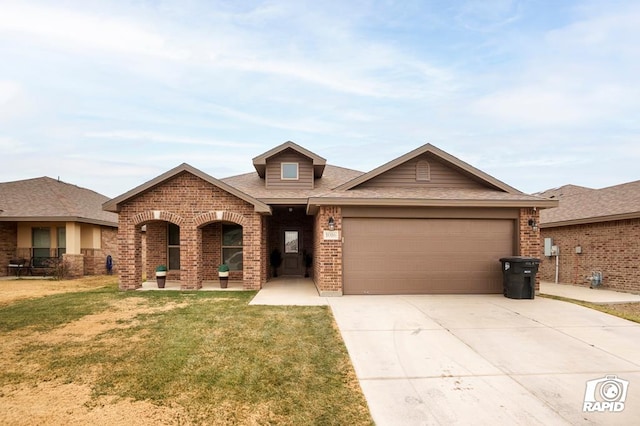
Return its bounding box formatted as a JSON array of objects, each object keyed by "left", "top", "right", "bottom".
[{"left": 327, "top": 295, "right": 640, "bottom": 426}]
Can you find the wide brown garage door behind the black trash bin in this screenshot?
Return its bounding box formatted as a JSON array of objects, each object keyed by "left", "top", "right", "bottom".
[{"left": 343, "top": 218, "right": 515, "bottom": 294}]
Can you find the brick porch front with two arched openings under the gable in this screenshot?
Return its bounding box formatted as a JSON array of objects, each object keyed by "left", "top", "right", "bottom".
[{"left": 118, "top": 172, "right": 268, "bottom": 290}]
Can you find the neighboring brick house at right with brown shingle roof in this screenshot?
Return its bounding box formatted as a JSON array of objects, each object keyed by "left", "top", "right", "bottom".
[{"left": 537, "top": 181, "right": 640, "bottom": 292}]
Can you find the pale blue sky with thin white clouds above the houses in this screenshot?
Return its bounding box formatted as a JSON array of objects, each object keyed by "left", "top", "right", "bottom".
[{"left": 0, "top": 0, "right": 640, "bottom": 197}]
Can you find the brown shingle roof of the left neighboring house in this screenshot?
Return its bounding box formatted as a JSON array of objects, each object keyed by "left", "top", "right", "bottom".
[{"left": 0, "top": 176, "right": 118, "bottom": 227}]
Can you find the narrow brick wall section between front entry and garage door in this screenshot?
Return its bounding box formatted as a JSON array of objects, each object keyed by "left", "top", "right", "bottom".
[{"left": 313, "top": 206, "right": 342, "bottom": 295}]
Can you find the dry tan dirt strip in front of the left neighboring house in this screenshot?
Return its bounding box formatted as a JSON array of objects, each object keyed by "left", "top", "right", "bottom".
[{"left": 0, "top": 275, "right": 118, "bottom": 305}]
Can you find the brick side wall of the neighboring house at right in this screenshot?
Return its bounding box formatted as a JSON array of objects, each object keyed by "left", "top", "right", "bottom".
[{"left": 540, "top": 219, "right": 640, "bottom": 293}]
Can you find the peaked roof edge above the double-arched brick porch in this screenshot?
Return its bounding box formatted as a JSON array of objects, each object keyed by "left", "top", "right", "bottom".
[{"left": 102, "top": 163, "right": 271, "bottom": 213}]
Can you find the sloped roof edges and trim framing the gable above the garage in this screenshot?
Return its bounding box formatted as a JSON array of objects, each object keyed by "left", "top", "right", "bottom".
[{"left": 338, "top": 143, "right": 520, "bottom": 193}]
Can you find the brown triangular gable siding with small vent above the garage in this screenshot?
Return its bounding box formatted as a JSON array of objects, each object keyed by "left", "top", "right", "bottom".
[{"left": 357, "top": 153, "right": 484, "bottom": 189}]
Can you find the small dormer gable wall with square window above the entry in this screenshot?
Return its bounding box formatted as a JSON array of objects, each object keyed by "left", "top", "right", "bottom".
[{"left": 265, "top": 148, "right": 314, "bottom": 189}]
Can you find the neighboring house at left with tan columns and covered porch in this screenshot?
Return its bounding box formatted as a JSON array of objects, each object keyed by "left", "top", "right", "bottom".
[{"left": 0, "top": 177, "right": 118, "bottom": 277}]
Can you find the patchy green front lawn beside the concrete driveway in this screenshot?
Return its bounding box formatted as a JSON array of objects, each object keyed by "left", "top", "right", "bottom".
[{"left": 0, "top": 287, "right": 372, "bottom": 425}]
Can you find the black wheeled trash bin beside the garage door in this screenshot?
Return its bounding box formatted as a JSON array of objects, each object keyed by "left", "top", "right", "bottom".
[{"left": 500, "top": 256, "right": 540, "bottom": 299}]
